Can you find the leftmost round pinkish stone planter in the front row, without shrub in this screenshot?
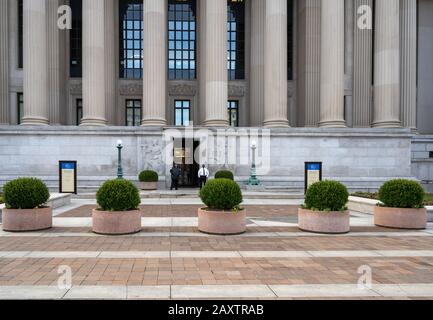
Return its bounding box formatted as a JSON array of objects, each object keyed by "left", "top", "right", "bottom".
[{"left": 3, "top": 207, "right": 53, "bottom": 232}]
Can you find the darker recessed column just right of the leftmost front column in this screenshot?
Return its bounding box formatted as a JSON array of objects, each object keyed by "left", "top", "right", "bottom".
[{"left": 47, "top": 0, "right": 66, "bottom": 125}]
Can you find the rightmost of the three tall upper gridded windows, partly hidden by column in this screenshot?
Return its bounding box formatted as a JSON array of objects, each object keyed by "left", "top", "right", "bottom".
[{"left": 227, "top": 0, "right": 245, "bottom": 80}]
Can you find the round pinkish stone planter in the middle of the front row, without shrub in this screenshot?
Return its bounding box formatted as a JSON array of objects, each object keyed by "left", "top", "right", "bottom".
[{"left": 198, "top": 208, "right": 247, "bottom": 235}]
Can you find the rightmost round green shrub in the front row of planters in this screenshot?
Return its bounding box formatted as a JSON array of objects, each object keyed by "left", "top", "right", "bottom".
[{"left": 379, "top": 179, "right": 425, "bottom": 209}]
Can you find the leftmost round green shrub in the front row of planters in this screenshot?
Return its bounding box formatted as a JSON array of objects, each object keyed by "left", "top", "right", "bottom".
[{"left": 3, "top": 178, "right": 50, "bottom": 209}]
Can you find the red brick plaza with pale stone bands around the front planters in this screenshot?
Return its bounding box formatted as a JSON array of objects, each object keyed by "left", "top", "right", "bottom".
[{"left": 0, "top": 200, "right": 433, "bottom": 299}]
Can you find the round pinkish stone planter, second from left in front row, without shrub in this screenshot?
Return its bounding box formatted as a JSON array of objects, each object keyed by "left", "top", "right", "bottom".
[{"left": 92, "top": 209, "right": 141, "bottom": 235}]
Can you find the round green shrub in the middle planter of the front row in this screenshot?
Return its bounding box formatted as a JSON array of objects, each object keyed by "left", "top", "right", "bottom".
[{"left": 200, "top": 179, "right": 243, "bottom": 210}]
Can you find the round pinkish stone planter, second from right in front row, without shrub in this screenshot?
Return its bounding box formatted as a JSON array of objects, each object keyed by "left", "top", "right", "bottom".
[{"left": 298, "top": 209, "right": 350, "bottom": 234}]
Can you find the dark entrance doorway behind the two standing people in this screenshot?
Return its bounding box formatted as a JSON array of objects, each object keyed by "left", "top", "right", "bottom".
[{"left": 173, "top": 139, "right": 200, "bottom": 188}]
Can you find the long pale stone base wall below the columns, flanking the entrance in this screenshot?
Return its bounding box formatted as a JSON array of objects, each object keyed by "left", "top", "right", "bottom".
[{"left": 0, "top": 126, "right": 413, "bottom": 191}]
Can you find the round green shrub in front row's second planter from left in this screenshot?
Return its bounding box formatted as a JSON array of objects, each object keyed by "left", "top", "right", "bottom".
[{"left": 96, "top": 179, "right": 141, "bottom": 211}]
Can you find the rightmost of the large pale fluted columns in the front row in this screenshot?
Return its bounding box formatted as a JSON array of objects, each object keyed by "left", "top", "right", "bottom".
[{"left": 373, "top": 0, "right": 400, "bottom": 128}]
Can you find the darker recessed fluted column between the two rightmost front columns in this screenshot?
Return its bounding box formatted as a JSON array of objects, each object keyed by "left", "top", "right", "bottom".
[{"left": 353, "top": 0, "right": 373, "bottom": 128}]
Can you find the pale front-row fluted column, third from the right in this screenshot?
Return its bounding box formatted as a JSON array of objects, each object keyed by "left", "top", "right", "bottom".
[{"left": 263, "top": 0, "right": 289, "bottom": 127}]
